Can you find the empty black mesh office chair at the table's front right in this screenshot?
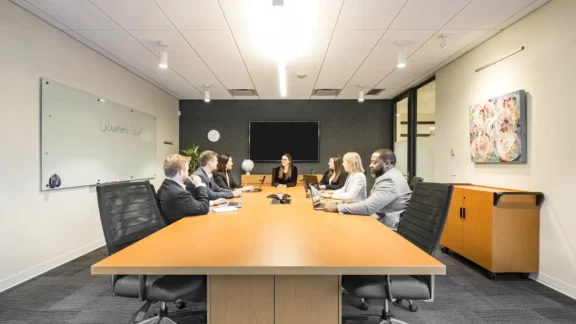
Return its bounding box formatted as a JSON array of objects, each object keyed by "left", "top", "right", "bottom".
[{"left": 342, "top": 182, "right": 453, "bottom": 323}]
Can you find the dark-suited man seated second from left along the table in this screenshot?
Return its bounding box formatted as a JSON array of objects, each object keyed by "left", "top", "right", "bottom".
[{"left": 186, "top": 151, "right": 242, "bottom": 201}]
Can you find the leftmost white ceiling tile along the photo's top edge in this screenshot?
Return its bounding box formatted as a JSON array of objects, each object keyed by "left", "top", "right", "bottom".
[{"left": 27, "top": 0, "right": 120, "bottom": 30}]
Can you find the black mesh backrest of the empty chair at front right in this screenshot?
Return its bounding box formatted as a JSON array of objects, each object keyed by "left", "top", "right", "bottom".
[{"left": 397, "top": 182, "right": 454, "bottom": 255}]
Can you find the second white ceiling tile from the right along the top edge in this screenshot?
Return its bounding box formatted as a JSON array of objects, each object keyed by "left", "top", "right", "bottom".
[{"left": 390, "top": 0, "right": 472, "bottom": 29}]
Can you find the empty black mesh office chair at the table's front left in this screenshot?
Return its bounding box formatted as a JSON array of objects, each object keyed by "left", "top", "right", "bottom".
[{"left": 96, "top": 181, "right": 206, "bottom": 324}]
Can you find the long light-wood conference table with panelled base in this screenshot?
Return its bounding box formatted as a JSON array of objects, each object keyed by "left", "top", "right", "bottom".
[{"left": 91, "top": 186, "right": 446, "bottom": 324}]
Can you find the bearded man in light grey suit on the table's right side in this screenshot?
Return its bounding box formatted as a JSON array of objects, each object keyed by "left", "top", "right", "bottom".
[{"left": 325, "top": 149, "right": 412, "bottom": 229}]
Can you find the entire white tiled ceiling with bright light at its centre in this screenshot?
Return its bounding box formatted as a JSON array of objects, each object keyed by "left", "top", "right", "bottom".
[{"left": 12, "top": 0, "right": 549, "bottom": 100}]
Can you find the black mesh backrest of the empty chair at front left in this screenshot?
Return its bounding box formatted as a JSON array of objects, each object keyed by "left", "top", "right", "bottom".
[{"left": 96, "top": 181, "right": 166, "bottom": 255}]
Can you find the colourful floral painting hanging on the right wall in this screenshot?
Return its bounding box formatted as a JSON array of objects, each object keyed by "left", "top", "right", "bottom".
[{"left": 470, "top": 90, "right": 527, "bottom": 163}]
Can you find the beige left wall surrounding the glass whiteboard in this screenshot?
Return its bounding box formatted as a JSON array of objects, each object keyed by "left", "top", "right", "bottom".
[{"left": 0, "top": 0, "right": 178, "bottom": 291}]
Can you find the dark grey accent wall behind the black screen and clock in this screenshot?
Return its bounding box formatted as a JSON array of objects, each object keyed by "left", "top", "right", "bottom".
[{"left": 180, "top": 100, "right": 393, "bottom": 190}]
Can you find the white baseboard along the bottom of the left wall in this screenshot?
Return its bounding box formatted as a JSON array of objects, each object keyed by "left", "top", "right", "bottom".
[{"left": 0, "top": 240, "right": 105, "bottom": 292}]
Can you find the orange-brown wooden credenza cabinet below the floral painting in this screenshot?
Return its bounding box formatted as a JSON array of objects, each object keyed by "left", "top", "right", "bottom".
[{"left": 440, "top": 185, "right": 544, "bottom": 278}]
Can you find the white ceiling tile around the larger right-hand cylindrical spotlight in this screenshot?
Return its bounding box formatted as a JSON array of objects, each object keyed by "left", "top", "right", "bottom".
[{"left": 360, "top": 30, "right": 436, "bottom": 70}]
